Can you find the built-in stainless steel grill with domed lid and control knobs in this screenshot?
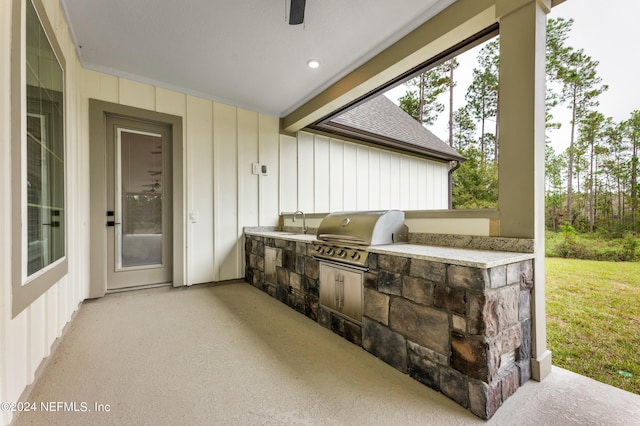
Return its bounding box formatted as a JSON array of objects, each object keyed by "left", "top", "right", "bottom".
[{"left": 313, "top": 210, "right": 408, "bottom": 268}]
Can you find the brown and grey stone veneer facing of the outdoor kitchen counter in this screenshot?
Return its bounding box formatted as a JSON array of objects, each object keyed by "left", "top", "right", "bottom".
[{"left": 245, "top": 235, "right": 533, "bottom": 419}]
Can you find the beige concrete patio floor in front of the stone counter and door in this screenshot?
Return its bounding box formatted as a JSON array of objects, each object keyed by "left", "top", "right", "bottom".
[{"left": 14, "top": 282, "right": 640, "bottom": 425}]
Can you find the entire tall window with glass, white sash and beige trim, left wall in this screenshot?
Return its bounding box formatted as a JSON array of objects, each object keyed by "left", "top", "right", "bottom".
[{"left": 12, "top": 0, "right": 67, "bottom": 315}]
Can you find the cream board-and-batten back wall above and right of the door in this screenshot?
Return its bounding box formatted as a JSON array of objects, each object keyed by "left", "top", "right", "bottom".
[{"left": 82, "top": 70, "right": 279, "bottom": 284}]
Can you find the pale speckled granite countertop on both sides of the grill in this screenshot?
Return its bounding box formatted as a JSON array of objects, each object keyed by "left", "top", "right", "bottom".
[{"left": 245, "top": 228, "right": 535, "bottom": 268}]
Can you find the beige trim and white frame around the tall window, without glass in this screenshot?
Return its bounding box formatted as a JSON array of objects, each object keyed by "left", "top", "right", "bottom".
[{"left": 11, "top": 0, "right": 69, "bottom": 318}]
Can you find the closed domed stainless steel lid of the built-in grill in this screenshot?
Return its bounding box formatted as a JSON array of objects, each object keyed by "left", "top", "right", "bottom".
[{"left": 317, "top": 210, "right": 409, "bottom": 246}]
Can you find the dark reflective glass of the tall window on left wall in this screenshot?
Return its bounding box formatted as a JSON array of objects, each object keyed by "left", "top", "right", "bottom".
[{"left": 23, "top": 2, "right": 65, "bottom": 276}]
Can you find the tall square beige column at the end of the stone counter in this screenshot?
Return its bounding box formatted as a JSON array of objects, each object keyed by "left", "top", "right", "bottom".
[{"left": 496, "top": 0, "right": 551, "bottom": 380}]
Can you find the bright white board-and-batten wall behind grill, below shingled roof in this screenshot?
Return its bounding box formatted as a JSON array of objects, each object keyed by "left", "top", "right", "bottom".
[{"left": 280, "top": 132, "right": 449, "bottom": 213}]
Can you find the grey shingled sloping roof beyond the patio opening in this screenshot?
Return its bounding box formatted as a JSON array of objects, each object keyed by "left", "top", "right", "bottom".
[{"left": 315, "top": 95, "right": 464, "bottom": 161}]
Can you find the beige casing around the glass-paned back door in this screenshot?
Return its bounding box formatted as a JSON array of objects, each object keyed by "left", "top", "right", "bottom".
[{"left": 88, "top": 99, "right": 186, "bottom": 299}]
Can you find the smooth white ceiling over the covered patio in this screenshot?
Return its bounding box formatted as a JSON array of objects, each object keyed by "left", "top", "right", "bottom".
[{"left": 61, "top": 0, "right": 455, "bottom": 117}]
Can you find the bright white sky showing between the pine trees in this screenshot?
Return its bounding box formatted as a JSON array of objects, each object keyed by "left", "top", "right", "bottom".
[{"left": 387, "top": 0, "right": 640, "bottom": 153}]
